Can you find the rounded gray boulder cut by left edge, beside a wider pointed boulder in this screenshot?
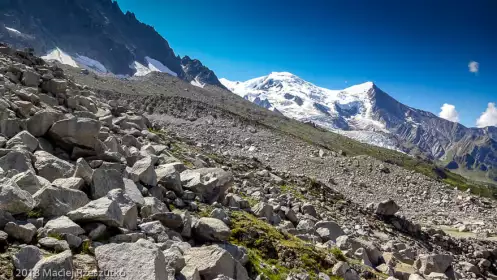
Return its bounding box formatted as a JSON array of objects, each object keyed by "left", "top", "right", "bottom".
[{"left": 0, "top": 180, "right": 35, "bottom": 215}]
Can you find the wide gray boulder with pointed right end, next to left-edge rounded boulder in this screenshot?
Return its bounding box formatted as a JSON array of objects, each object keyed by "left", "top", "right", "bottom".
[{"left": 33, "top": 186, "right": 90, "bottom": 217}]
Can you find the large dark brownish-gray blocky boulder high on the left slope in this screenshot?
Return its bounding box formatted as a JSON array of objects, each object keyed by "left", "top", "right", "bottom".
[{"left": 48, "top": 118, "right": 101, "bottom": 150}]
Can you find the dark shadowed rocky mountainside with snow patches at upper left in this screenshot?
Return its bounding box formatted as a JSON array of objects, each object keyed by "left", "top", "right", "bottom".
[{"left": 0, "top": 0, "right": 222, "bottom": 87}]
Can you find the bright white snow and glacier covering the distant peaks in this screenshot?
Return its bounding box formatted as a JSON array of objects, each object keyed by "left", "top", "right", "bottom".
[{"left": 220, "top": 72, "right": 398, "bottom": 150}]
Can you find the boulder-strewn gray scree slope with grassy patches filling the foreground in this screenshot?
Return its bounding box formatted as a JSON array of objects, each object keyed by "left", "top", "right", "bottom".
[{"left": 0, "top": 43, "right": 497, "bottom": 280}]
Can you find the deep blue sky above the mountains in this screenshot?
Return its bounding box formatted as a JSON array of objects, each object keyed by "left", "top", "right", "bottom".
[{"left": 117, "top": 0, "right": 497, "bottom": 126}]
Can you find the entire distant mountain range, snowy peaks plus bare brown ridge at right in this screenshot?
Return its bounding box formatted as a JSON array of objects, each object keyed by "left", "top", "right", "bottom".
[{"left": 220, "top": 72, "right": 497, "bottom": 181}]
